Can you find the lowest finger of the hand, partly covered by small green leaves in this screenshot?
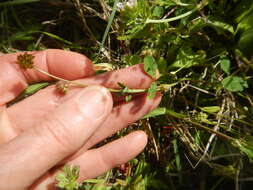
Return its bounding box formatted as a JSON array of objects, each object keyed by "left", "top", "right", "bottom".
[{"left": 31, "top": 131, "right": 147, "bottom": 190}]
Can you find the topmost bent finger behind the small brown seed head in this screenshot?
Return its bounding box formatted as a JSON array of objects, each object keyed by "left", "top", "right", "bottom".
[{"left": 0, "top": 49, "right": 94, "bottom": 105}]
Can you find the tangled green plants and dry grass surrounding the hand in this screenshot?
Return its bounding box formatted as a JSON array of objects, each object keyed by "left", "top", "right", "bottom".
[{"left": 0, "top": 0, "right": 253, "bottom": 190}]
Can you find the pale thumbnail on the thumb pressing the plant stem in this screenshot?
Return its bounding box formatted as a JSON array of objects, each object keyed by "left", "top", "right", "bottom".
[{"left": 77, "top": 86, "right": 110, "bottom": 120}]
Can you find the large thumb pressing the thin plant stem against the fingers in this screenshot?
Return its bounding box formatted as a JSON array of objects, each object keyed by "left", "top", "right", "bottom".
[{"left": 0, "top": 86, "right": 112, "bottom": 189}]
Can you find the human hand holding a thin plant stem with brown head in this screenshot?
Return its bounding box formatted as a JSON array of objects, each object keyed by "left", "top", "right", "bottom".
[{"left": 0, "top": 50, "right": 160, "bottom": 190}]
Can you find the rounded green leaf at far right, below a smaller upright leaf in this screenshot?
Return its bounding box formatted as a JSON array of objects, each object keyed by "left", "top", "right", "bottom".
[{"left": 222, "top": 76, "right": 248, "bottom": 92}]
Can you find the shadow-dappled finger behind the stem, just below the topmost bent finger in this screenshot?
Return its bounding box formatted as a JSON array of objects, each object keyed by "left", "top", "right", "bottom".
[{"left": 7, "top": 65, "right": 153, "bottom": 133}]
